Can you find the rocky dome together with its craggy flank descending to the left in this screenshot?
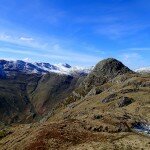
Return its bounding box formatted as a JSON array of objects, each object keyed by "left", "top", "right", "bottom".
[{"left": 67, "top": 58, "right": 134, "bottom": 101}]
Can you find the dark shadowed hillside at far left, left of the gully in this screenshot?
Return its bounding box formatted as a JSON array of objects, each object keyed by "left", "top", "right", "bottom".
[{"left": 0, "top": 74, "right": 39, "bottom": 123}]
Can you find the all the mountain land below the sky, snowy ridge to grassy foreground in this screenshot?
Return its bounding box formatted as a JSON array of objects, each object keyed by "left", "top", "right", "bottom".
[{"left": 0, "top": 58, "right": 150, "bottom": 150}]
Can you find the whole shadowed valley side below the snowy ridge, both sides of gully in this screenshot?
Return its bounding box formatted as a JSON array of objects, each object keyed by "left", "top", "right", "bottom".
[{"left": 0, "top": 69, "right": 84, "bottom": 124}]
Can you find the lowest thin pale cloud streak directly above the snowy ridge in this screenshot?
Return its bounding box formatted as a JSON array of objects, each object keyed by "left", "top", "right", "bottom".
[{"left": 0, "top": 46, "right": 102, "bottom": 66}]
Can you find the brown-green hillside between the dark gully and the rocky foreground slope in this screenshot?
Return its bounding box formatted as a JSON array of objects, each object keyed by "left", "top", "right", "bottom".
[{"left": 31, "top": 73, "right": 79, "bottom": 115}]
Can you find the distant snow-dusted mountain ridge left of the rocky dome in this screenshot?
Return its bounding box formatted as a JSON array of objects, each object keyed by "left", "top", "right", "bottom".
[{"left": 0, "top": 60, "right": 92, "bottom": 76}]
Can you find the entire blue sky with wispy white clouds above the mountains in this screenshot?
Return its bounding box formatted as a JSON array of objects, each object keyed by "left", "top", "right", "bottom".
[{"left": 0, "top": 0, "right": 150, "bottom": 69}]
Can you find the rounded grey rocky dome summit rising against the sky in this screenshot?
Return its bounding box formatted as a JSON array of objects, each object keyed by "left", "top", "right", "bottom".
[{"left": 84, "top": 58, "right": 133, "bottom": 87}]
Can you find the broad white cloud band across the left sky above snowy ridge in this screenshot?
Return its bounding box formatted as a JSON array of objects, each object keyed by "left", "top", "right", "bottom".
[{"left": 0, "top": 30, "right": 103, "bottom": 65}]
